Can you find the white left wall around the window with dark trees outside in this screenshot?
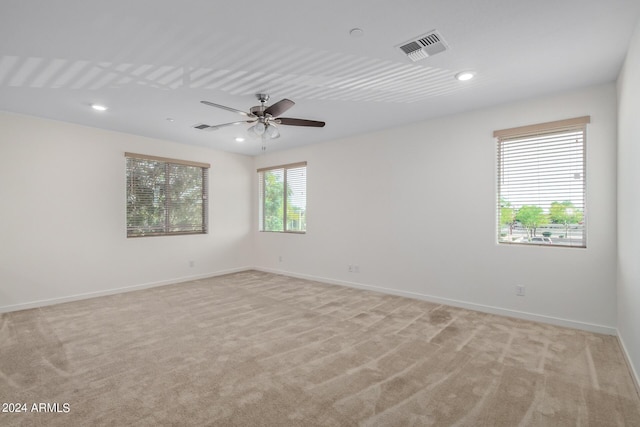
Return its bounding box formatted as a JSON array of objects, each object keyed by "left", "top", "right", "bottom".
[{"left": 0, "top": 112, "right": 255, "bottom": 311}]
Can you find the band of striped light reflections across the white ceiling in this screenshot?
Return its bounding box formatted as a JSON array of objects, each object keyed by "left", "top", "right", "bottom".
[{"left": 0, "top": 50, "right": 470, "bottom": 103}]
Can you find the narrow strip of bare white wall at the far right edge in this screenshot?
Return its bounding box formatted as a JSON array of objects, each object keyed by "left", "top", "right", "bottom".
[{"left": 618, "top": 17, "right": 640, "bottom": 383}]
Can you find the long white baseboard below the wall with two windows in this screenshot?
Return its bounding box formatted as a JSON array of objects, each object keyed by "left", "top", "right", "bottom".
[{"left": 254, "top": 267, "right": 617, "bottom": 335}]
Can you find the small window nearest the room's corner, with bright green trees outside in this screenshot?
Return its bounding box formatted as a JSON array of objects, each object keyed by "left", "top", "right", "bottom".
[{"left": 258, "top": 162, "right": 307, "bottom": 233}]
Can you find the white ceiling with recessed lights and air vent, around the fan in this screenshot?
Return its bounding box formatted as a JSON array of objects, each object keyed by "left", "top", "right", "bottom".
[{"left": 0, "top": 0, "right": 640, "bottom": 155}]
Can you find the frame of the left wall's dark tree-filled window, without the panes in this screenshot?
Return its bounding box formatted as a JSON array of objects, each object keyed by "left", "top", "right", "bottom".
[{"left": 124, "top": 152, "right": 211, "bottom": 238}]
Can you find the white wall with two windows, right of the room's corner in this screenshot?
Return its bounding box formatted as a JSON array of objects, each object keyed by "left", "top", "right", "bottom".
[{"left": 255, "top": 84, "right": 617, "bottom": 333}]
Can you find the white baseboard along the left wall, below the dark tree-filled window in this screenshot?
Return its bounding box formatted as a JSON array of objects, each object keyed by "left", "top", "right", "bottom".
[{"left": 0, "top": 267, "right": 252, "bottom": 313}]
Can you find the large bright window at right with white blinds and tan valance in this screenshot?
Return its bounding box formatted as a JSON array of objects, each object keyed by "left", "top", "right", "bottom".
[{"left": 494, "top": 116, "right": 590, "bottom": 248}]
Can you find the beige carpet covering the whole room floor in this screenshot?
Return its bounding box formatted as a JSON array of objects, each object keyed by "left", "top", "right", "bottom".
[{"left": 0, "top": 271, "right": 640, "bottom": 426}]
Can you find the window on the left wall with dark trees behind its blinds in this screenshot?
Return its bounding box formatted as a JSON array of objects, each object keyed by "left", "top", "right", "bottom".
[{"left": 125, "top": 153, "right": 209, "bottom": 237}]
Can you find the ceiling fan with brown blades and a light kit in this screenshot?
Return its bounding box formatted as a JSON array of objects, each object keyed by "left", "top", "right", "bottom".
[{"left": 194, "top": 93, "right": 325, "bottom": 143}]
